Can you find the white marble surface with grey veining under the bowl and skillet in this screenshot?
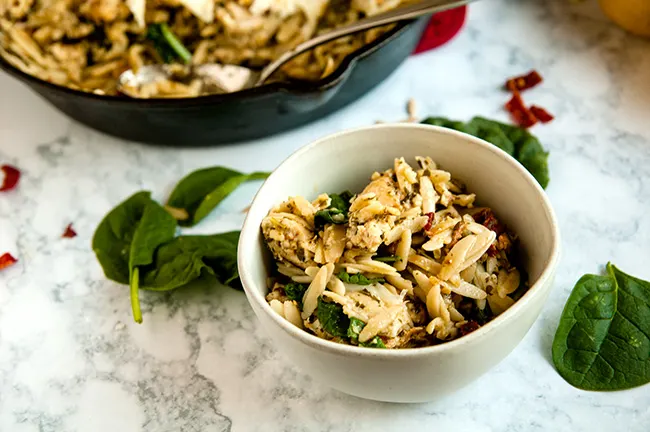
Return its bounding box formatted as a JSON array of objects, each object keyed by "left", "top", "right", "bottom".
[{"left": 0, "top": 0, "right": 650, "bottom": 432}]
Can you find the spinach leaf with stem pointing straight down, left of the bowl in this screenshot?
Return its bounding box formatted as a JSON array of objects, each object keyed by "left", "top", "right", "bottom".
[{"left": 129, "top": 200, "right": 176, "bottom": 323}]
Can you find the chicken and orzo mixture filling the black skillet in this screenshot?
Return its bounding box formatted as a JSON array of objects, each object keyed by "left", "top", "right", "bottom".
[{"left": 0, "top": 0, "right": 406, "bottom": 97}]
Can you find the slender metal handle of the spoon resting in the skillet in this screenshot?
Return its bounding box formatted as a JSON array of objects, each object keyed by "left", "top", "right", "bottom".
[{"left": 255, "top": 0, "right": 476, "bottom": 86}]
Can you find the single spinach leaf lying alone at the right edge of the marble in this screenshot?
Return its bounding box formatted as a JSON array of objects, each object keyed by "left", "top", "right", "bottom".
[{"left": 553, "top": 263, "right": 650, "bottom": 391}]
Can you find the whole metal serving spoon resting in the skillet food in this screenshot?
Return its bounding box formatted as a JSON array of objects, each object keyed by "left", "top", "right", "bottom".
[{"left": 118, "top": 0, "right": 476, "bottom": 98}]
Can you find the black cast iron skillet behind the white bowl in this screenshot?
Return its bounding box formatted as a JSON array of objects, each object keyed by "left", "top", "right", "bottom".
[{"left": 0, "top": 17, "right": 428, "bottom": 147}]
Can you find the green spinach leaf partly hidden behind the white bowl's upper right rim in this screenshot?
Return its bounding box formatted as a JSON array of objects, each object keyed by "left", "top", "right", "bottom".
[{"left": 422, "top": 117, "right": 550, "bottom": 189}]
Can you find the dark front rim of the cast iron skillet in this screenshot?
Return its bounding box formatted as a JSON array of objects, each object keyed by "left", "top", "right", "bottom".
[{"left": 0, "top": 19, "right": 418, "bottom": 107}]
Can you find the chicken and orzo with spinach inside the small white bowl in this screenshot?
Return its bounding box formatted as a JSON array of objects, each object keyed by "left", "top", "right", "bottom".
[{"left": 261, "top": 157, "right": 528, "bottom": 348}]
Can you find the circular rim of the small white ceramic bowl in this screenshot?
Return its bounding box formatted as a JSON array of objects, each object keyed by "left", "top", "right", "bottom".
[{"left": 237, "top": 123, "right": 561, "bottom": 359}]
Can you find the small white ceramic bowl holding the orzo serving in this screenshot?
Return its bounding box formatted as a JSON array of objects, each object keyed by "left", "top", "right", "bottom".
[{"left": 238, "top": 124, "right": 560, "bottom": 402}]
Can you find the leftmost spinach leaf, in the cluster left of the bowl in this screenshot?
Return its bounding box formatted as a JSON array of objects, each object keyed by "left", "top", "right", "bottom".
[{"left": 92, "top": 191, "right": 151, "bottom": 285}]
